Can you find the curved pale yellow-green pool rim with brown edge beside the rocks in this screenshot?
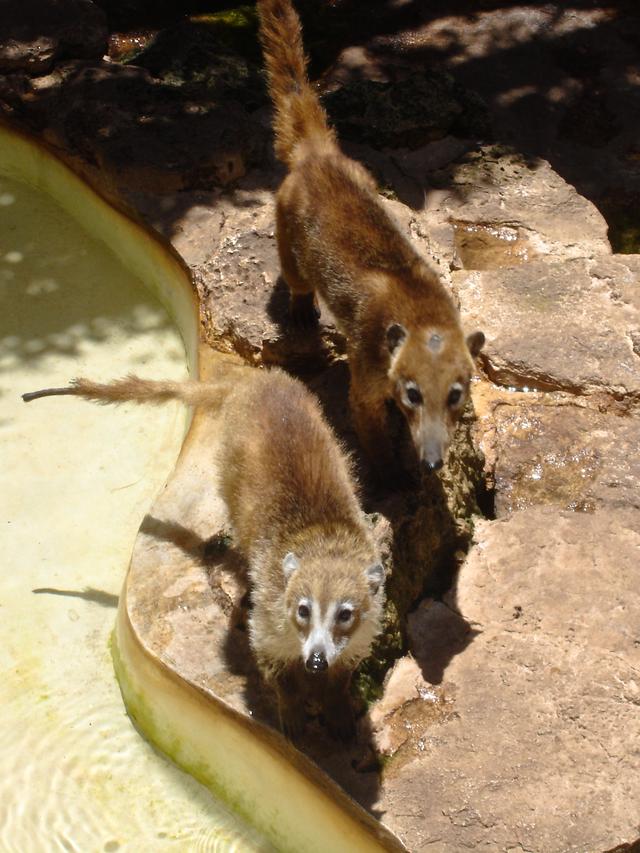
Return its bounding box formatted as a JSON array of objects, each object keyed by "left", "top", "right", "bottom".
[{"left": 0, "top": 120, "right": 405, "bottom": 853}]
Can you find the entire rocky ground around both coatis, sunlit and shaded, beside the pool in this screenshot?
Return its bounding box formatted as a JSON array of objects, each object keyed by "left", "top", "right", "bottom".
[{"left": 0, "top": 0, "right": 640, "bottom": 853}]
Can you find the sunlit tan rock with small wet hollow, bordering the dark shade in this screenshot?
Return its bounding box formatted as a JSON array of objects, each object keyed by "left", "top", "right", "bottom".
[{"left": 408, "top": 146, "right": 611, "bottom": 269}]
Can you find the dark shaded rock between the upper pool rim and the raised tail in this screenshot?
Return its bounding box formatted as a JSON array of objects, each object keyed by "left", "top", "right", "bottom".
[{"left": 0, "top": 60, "right": 266, "bottom": 195}]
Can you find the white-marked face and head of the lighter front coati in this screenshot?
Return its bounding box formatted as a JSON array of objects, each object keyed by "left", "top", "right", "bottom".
[{"left": 282, "top": 552, "right": 384, "bottom": 675}]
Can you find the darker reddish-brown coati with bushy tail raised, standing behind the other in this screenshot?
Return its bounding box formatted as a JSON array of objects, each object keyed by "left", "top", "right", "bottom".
[{"left": 258, "top": 0, "right": 484, "bottom": 477}]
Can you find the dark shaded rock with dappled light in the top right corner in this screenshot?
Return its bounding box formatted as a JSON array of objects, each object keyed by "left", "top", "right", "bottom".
[{"left": 318, "top": 0, "right": 640, "bottom": 251}]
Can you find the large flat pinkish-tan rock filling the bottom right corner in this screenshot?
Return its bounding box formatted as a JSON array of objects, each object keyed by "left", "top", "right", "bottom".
[{"left": 374, "top": 510, "right": 640, "bottom": 853}]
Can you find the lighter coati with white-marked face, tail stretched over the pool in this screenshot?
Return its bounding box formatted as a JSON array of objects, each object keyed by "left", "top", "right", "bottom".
[{"left": 23, "top": 366, "right": 384, "bottom": 737}]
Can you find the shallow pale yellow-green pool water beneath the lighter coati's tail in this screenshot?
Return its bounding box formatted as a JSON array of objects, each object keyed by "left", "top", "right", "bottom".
[{"left": 0, "top": 176, "right": 266, "bottom": 853}]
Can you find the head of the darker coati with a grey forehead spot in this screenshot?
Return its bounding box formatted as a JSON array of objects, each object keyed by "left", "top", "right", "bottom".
[{"left": 386, "top": 323, "right": 484, "bottom": 471}]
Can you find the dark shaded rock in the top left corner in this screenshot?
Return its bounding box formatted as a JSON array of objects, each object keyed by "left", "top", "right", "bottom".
[{"left": 0, "top": 0, "right": 107, "bottom": 74}]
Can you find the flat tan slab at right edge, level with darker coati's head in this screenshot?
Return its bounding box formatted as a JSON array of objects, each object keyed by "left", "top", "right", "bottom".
[{"left": 453, "top": 255, "right": 640, "bottom": 399}]
